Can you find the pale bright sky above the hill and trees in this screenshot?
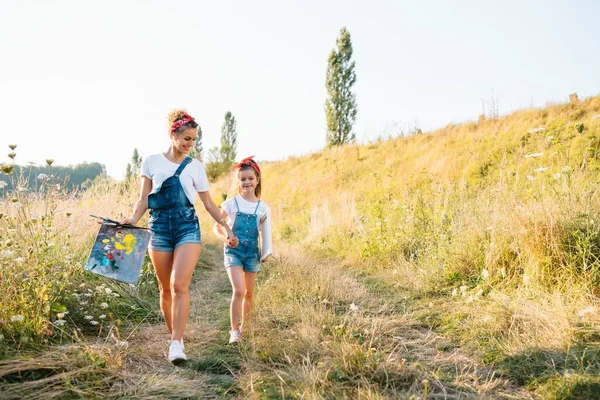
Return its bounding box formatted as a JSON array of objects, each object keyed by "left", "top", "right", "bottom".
[{"left": 0, "top": 0, "right": 600, "bottom": 179}]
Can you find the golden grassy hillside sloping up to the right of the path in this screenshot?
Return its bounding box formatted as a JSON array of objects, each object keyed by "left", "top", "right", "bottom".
[{"left": 217, "top": 96, "right": 600, "bottom": 398}]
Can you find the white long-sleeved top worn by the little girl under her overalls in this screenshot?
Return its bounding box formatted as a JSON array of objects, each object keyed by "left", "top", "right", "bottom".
[{"left": 221, "top": 194, "right": 273, "bottom": 261}]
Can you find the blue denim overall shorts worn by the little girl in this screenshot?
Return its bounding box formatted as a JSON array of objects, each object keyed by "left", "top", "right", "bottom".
[{"left": 223, "top": 197, "right": 260, "bottom": 272}]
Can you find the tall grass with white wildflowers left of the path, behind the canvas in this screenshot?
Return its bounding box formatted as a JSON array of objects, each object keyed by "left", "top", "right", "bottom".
[{"left": 0, "top": 153, "right": 158, "bottom": 357}]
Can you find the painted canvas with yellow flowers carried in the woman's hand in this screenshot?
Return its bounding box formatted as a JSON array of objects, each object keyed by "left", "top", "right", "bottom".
[{"left": 85, "top": 217, "right": 151, "bottom": 285}]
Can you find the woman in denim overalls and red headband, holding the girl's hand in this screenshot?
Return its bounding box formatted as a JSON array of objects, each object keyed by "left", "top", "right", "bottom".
[{"left": 121, "top": 110, "right": 235, "bottom": 364}]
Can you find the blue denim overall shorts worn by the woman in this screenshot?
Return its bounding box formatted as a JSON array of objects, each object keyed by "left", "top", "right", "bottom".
[{"left": 148, "top": 157, "right": 200, "bottom": 251}]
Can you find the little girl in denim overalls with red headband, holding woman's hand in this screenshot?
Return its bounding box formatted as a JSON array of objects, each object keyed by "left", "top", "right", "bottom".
[{"left": 213, "top": 156, "right": 272, "bottom": 344}]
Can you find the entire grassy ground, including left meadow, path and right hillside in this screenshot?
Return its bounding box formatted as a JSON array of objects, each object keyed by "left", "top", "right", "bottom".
[{"left": 0, "top": 96, "right": 600, "bottom": 399}]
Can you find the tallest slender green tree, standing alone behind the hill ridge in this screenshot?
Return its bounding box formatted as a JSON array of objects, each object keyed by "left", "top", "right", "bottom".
[{"left": 325, "top": 27, "right": 357, "bottom": 147}]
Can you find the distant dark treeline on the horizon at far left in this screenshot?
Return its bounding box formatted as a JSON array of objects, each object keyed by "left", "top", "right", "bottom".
[{"left": 0, "top": 162, "right": 106, "bottom": 191}]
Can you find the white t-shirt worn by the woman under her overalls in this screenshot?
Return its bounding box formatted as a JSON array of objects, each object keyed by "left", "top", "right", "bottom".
[{"left": 140, "top": 153, "right": 209, "bottom": 205}]
